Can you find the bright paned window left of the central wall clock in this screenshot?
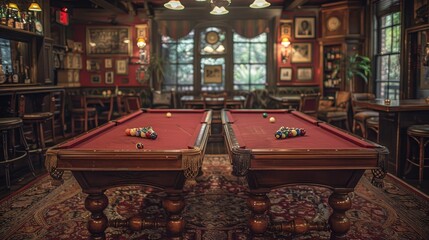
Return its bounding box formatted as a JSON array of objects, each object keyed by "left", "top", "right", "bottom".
[{"left": 161, "top": 31, "right": 194, "bottom": 91}]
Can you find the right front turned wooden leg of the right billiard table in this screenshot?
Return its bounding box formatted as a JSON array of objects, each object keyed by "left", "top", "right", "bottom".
[{"left": 329, "top": 189, "right": 352, "bottom": 240}]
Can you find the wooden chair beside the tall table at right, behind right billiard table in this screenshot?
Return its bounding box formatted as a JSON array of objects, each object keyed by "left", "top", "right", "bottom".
[{"left": 351, "top": 93, "right": 379, "bottom": 138}]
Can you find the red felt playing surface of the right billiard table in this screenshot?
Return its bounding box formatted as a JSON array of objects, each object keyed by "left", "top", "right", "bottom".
[{"left": 228, "top": 110, "right": 374, "bottom": 149}]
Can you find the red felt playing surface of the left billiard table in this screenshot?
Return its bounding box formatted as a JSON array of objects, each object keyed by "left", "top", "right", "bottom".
[{"left": 62, "top": 110, "right": 207, "bottom": 151}]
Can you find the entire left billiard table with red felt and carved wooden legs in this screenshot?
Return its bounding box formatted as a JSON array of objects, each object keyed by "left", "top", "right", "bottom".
[{"left": 45, "top": 109, "right": 212, "bottom": 239}]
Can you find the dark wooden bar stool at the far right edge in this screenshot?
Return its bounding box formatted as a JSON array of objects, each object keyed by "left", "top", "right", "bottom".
[{"left": 404, "top": 124, "right": 429, "bottom": 185}]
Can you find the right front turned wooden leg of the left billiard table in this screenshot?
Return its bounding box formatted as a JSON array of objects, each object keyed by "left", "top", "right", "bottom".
[{"left": 162, "top": 192, "right": 185, "bottom": 239}]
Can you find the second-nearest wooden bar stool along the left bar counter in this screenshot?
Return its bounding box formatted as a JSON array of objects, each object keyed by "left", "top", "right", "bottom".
[{"left": 19, "top": 95, "right": 55, "bottom": 160}]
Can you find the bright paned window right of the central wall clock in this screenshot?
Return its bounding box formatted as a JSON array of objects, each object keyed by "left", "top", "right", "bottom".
[{"left": 233, "top": 33, "right": 267, "bottom": 91}]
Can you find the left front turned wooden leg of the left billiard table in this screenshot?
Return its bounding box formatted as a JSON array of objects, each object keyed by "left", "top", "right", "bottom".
[{"left": 85, "top": 191, "right": 109, "bottom": 239}]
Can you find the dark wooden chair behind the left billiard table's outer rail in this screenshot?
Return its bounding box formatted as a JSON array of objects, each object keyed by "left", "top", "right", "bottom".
[{"left": 70, "top": 95, "right": 98, "bottom": 135}]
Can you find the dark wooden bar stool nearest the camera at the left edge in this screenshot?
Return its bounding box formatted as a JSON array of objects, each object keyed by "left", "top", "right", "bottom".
[{"left": 0, "top": 117, "right": 36, "bottom": 189}]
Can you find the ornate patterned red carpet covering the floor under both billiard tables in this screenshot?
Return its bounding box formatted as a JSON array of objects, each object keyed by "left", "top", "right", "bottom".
[{"left": 0, "top": 155, "right": 429, "bottom": 240}]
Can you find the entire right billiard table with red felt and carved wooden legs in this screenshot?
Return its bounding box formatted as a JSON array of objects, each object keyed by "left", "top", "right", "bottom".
[{"left": 221, "top": 109, "right": 388, "bottom": 239}]
